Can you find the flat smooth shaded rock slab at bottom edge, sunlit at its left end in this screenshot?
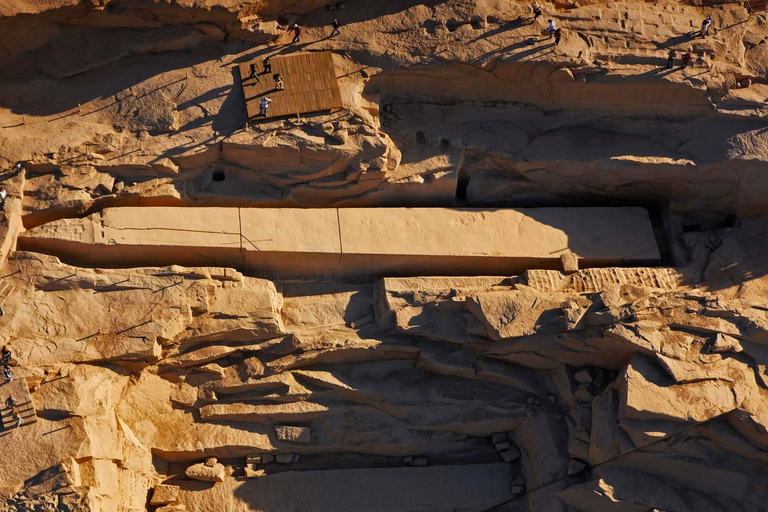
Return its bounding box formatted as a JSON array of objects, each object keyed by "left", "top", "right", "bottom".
[{"left": 172, "top": 463, "right": 513, "bottom": 512}]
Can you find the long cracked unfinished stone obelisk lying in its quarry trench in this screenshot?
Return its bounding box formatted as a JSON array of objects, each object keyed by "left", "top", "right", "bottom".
[{"left": 18, "top": 207, "right": 660, "bottom": 276}]
